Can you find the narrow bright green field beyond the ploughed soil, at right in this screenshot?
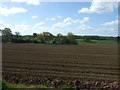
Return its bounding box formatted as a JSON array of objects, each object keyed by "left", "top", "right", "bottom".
[{"left": 77, "top": 39, "right": 117, "bottom": 44}]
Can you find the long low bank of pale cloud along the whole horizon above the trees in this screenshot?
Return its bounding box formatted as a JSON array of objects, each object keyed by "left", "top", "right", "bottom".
[{"left": 0, "top": 20, "right": 118, "bottom": 36}]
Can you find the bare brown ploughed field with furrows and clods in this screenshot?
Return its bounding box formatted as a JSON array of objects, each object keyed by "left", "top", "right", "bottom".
[{"left": 2, "top": 44, "right": 119, "bottom": 88}]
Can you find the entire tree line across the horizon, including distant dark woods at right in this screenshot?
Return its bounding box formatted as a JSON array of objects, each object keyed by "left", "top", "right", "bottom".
[{"left": 0, "top": 28, "right": 120, "bottom": 44}]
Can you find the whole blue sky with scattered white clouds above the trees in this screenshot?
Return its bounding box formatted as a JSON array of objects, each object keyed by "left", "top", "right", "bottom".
[{"left": 0, "top": 0, "right": 120, "bottom": 36}]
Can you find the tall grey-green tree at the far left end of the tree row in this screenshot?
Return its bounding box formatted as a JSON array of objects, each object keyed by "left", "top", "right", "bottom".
[{"left": 1, "top": 28, "right": 12, "bottom": 42}]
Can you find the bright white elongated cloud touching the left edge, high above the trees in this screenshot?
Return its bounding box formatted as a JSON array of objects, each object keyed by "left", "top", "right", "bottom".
[{"left": 0, "top": 7, "right": 27, "bottom": 16}]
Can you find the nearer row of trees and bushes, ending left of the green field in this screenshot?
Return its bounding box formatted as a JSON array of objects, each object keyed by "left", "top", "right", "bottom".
[{"left": 0, "top": 28, "right": 77, "bottom": 44}]
